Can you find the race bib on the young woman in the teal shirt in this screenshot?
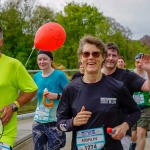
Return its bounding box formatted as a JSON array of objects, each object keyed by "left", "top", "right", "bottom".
[{"left": 35, "top": 106, "right": 51, "bottom": 121}]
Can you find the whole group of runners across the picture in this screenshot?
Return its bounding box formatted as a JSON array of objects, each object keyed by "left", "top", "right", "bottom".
[{"left": 0, "top": 24, "right": 150, "bottom": 150}]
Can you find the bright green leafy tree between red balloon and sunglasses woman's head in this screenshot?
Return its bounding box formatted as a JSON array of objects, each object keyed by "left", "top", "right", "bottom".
[{"left": 54, "top": 2, "right": 105, "bottom": 68}]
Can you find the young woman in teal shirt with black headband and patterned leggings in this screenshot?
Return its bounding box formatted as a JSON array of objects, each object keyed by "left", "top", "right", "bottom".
[{"left": 32, "top": 50, "right": 68, "bottom": 150}]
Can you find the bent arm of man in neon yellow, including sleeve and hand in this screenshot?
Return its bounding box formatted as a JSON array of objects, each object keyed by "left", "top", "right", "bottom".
[{"left": 0, "top": 63, "right": 37, "bottom": 125}]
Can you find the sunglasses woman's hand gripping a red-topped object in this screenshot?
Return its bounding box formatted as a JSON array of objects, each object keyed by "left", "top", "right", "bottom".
[{"left": 112, "top": 122, "right": 129, "bottom": 140}]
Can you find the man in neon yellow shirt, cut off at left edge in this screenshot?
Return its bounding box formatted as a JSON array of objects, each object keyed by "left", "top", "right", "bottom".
[{"left": 0, "top": 27, "right": 37, "bottom": 150}]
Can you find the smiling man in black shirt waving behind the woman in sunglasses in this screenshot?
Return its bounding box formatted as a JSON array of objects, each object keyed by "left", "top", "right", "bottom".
[{"left": 102, "top": 42, "right": 150, "bottom": 150}]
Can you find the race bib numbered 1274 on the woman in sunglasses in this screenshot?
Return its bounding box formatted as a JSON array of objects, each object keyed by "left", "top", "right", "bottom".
[{"left": 76, "top": 128, "right": 105, "bottom": 150}]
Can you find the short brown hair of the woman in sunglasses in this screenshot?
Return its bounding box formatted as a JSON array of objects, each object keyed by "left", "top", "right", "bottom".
[{"left": 77, "top": 35, "right": 107, "bottom": 56}]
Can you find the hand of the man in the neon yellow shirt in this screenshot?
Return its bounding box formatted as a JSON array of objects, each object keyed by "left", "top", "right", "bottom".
[{"left": 0, "top": 105, "right": 13, "bottom": 125}]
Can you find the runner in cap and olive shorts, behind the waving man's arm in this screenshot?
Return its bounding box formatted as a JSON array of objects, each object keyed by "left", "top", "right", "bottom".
[{"left": 131, "top": 53, "right": 150, "bottom": 150}]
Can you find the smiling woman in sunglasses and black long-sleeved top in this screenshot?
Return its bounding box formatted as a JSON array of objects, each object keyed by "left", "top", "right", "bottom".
[{"left": 57, "top": 35, "right": 140, "bottom": 150}]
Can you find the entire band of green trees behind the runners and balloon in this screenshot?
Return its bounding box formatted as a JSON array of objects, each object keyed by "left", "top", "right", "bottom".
[{"left": 0, "top": 0, "right": 149, "bottom": 69}]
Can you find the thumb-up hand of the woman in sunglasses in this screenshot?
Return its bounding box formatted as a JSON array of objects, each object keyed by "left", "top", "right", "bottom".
[{"left": 73, "top": 106, "right": 92, "bottom": 126}]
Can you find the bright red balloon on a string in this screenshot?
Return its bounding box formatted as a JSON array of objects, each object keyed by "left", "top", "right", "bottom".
[{"left": 34, "top": 22, "right": 66, "bottom": 51}]
